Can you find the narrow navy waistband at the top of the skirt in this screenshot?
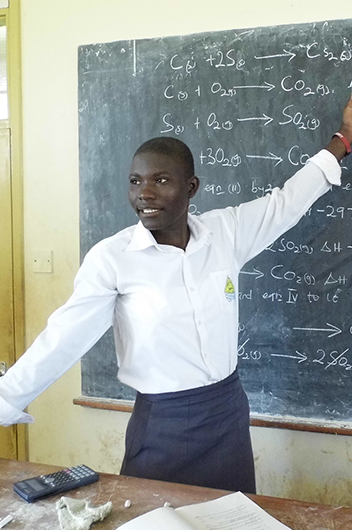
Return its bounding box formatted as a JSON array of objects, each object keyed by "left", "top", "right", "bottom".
[{"left": 136, "top": 368, "right": 239, "bottom": 402}]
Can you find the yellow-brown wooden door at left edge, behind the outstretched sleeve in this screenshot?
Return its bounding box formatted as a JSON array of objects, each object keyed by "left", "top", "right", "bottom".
[{"left": 0, "top": 128, "right": 17, "bottom": 458}]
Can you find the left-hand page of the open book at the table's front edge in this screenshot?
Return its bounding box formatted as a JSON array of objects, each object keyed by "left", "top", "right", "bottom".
[{"left": 120, "top": 507, "right": 194, "bottom": 530}]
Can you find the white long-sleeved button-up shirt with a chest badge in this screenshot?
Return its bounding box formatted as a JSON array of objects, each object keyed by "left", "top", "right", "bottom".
[{"left": 0, "top": 150, "right": 341, "bottom": 425}]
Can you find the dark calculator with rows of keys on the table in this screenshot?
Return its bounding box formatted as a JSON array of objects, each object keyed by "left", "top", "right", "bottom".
[{"left": 13, "top": 465, "right": 99, "bottom": 502}]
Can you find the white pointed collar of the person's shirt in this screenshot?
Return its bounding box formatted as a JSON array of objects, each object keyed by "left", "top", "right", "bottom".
[{"left": 126, "top": 214, "right": 212, "bottom": 252}]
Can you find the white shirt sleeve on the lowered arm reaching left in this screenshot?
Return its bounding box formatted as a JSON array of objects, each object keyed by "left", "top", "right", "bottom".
[{"left": 0, "top": 248, "right": 117, "bottom": 426}]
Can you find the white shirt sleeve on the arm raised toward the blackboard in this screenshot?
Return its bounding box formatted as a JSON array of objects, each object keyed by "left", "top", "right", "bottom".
[{"left": 233, "top": 150, "right": 341, "bottom": 268}]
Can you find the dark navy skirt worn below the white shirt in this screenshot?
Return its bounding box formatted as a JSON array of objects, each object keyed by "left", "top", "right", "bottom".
[{"left": 120, "top": 370, "right": 255, "bottom": 493}]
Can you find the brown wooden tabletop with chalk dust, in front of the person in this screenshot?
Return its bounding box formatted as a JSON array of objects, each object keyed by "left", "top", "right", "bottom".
[{"left": 0, "top": 459, "right": 352, "bottom": 530}]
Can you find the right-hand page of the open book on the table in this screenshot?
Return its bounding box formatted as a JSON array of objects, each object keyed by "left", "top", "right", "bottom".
[{"left": 176, "top": 492, "right": 291, "bottom": 530}]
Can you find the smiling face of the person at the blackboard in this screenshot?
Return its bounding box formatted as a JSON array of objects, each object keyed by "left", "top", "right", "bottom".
[{"left": 128, "top": 152, "right": 198, "bottom": 244}]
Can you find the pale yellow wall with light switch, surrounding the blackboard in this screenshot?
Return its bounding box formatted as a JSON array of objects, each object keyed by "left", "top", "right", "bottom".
[{"left": 21, "top": 0, "right": 352, "bottom": 505}]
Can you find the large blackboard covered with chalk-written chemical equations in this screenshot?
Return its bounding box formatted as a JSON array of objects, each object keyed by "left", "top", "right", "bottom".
[{"left": 78, "top": 20, "right": 352, "bottom": 425}]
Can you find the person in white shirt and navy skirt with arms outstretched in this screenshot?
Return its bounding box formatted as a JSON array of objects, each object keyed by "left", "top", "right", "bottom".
[{"left": 0, "top": 95, "right": 352, "bottom": 493}]
